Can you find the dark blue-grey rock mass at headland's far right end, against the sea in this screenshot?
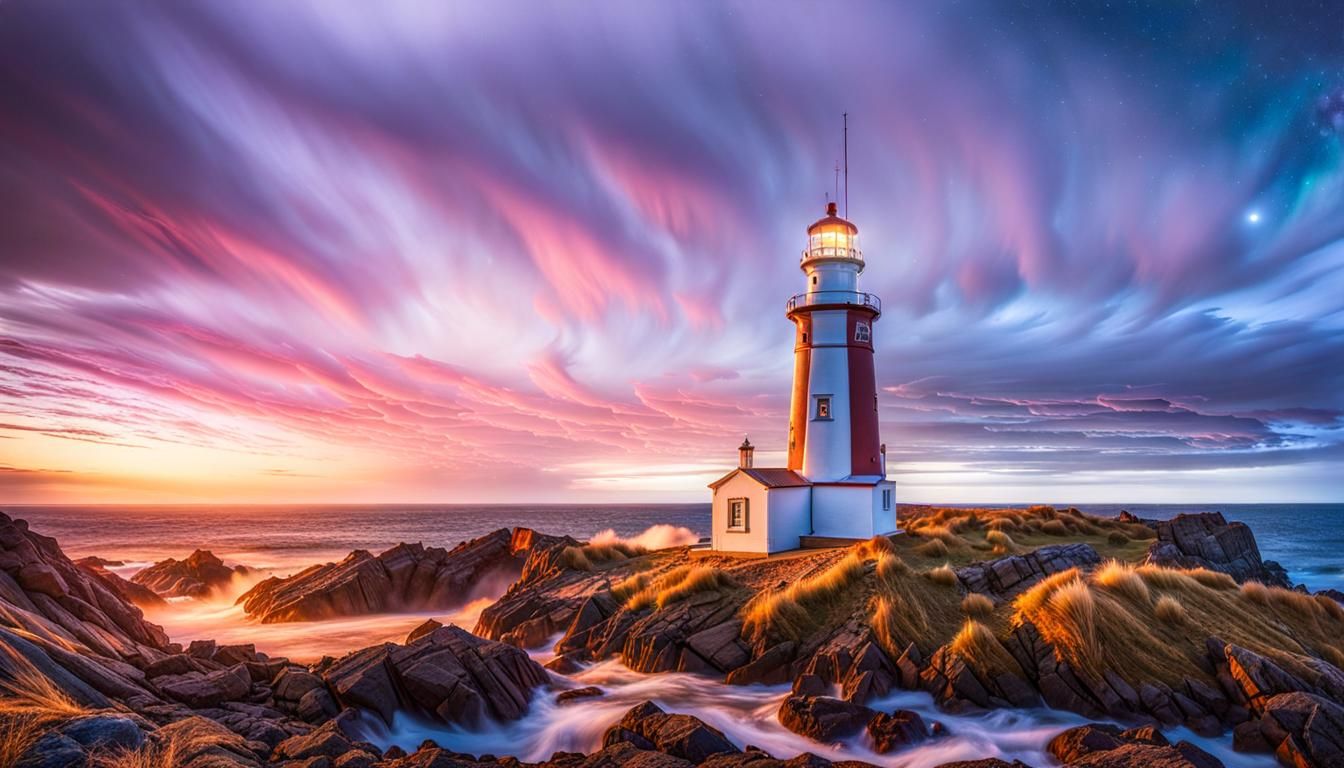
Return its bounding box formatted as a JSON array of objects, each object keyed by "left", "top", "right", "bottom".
[{"left": 1142, "top": 512, "right": 1292, "bottom": 588}]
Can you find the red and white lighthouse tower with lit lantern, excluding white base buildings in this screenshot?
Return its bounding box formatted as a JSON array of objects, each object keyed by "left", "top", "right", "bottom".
[{"left": 786, "top": 203, "right": 886, "bottom": 483}]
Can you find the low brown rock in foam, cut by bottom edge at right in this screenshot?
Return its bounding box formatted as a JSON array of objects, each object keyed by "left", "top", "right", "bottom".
[{"left": 1047, "top": 724, "right": 1223, "bottom": 768}]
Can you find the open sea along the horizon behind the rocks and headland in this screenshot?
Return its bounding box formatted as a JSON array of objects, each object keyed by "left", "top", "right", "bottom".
[{"left": 0, "top": 503, "right": 1344, "bottom": 590}]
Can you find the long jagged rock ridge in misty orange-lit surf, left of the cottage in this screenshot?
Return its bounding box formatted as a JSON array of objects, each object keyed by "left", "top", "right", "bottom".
[{"left": 238, "top": 529, "right": 550, "bottom": 624}]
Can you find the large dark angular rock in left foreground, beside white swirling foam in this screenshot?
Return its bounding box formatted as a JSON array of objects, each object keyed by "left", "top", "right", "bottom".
[{"left": 323, "top": 627, "right": 550, "bottom": 726}]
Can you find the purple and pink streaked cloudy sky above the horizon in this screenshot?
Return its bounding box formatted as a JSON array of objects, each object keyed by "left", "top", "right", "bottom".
[{"left": 0, "top": 0, "right": 1344, "bottom": 503}]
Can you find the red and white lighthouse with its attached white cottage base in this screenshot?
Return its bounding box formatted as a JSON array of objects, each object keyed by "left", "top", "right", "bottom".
[{"left": 710, "top": 203, "right": 898, "bottom": 554}]
